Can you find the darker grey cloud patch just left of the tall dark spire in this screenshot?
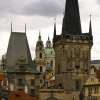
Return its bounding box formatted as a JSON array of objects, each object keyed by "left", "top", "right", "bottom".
[{"left": 23, "top": 0, "right": 65, "bottom": 16}]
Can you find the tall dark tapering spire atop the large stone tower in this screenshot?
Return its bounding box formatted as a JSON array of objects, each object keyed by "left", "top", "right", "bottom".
[{"left": 62, "top": 0, "right": 82, "bottom": 35}]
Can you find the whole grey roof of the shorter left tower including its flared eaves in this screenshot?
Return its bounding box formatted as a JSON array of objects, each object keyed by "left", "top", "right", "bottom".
[{"left": 6, "top": 32, "right": 38, "bottom": 73}]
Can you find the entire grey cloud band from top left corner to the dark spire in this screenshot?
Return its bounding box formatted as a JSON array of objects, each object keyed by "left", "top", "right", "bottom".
[{"left": 0, "top": 0, "right": 65, "bottom": 16}]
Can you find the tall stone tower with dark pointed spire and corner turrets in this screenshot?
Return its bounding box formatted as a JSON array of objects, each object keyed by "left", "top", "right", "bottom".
[{"left": 53, "top": 0, "right": 93, "bottom": 91}]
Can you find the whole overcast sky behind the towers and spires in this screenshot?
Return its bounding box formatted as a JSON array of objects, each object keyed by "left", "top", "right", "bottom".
[{"left": 0, "top": 0, "right": 100, "bottom": 59}]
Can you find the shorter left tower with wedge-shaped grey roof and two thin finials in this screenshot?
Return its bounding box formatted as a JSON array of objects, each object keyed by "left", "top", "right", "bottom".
[{"left": 6, "top": 25, "right": 39, "bottom": 95}]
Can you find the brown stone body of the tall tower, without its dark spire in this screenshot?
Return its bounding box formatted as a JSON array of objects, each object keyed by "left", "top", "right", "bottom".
[{"left": 54, "top": 36, "right": 92, "bottom": 90}]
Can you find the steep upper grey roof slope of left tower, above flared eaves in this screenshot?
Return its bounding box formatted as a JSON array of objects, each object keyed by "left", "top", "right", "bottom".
[{"left": 7, "top": 32, "right": 32, "bottom": 67}]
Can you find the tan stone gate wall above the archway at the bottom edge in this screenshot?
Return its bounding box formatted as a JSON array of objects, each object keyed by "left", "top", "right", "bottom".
[{"left": 39, "top": 89, "right": 79, "bottom": 100}]
